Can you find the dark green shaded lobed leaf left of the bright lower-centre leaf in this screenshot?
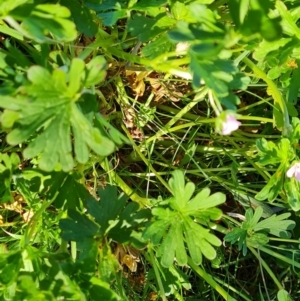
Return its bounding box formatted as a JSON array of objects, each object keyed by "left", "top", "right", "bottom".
[{"left": 60, "top": 185, "right": 151, "bottom": 248}]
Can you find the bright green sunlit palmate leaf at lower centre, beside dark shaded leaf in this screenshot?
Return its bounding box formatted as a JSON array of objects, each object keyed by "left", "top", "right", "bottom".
[{"left": 143, "top": 170, "right": 225, "bottom": 267}]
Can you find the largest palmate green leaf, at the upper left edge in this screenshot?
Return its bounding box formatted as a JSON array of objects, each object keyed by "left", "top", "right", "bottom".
[{"left": 0, "top": 57, "right": 114, "bottom": 171}]
